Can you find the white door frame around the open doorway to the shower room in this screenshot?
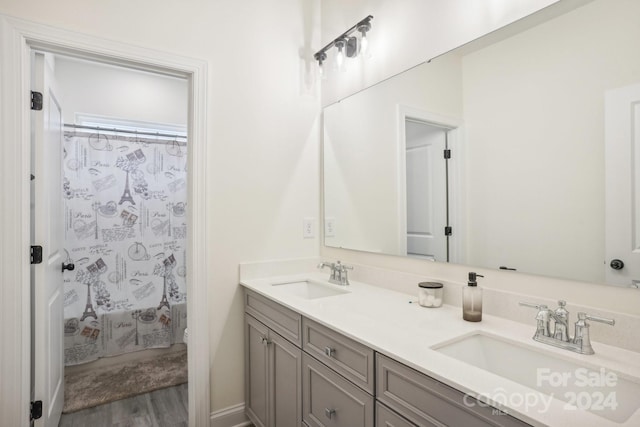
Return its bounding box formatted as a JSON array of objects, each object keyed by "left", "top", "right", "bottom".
[{"left": 0, "top": 14, "right": 211, "bottom": 427}]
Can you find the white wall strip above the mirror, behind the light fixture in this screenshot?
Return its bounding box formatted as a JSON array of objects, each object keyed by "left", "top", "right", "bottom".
[{"left": 321, "top": 0, "right": 560, "bottom": 105}]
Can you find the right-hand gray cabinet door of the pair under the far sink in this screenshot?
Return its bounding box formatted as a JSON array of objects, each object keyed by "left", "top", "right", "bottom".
[{"left": 268, "top": 331, "right": 302, "bottom": 427}]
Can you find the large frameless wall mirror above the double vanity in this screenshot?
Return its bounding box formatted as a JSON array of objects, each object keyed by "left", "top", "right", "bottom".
[{"left": 323, "top": 0, "right": 640, "bottom": 287}]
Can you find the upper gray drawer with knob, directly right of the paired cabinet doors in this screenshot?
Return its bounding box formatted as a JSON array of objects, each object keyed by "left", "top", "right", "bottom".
[{"left": 302, "top": 318, "right": 374, "bottom": 394}]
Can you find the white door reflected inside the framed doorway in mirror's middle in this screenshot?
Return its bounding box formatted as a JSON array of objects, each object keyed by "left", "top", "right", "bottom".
[{"left": 405, "top": 120, "right": 448, "bottom": 262}]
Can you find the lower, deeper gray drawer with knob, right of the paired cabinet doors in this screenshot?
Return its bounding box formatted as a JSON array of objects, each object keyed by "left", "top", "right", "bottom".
[{"left": 302, "top": 353, "right": 374, "bottom": 427}]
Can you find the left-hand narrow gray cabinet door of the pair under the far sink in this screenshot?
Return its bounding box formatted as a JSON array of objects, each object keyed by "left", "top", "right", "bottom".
[{"left": 245, "top": 315, "right": 269, "bottom": 427}]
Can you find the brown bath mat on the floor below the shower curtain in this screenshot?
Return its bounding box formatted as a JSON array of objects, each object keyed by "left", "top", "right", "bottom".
[{"left": 62, "top": 350, "right": 187, "bottom": 413}]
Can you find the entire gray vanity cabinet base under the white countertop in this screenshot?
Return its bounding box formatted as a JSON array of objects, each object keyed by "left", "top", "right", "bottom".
[{"left": 245, "top": 290, "right": 528, "bottom": 427}]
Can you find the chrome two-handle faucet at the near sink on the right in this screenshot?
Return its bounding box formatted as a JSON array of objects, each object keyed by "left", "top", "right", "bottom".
[{"left": 520, "top": 300, "right": 616, "bottom": 354}]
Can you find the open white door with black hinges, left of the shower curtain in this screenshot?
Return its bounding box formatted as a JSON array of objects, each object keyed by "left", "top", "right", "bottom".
[{"left": 31, "top": 53, "right": 64, "bottom": 427}]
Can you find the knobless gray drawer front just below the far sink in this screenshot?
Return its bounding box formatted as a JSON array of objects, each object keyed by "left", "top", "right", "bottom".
[{"left": 244, "top": 290, "right": 302, "bottom": 347}]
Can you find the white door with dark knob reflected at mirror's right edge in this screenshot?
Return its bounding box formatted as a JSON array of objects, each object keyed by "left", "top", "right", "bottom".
[{"left": 605, "top": 84, "right": 640, "bottom": 287}]
